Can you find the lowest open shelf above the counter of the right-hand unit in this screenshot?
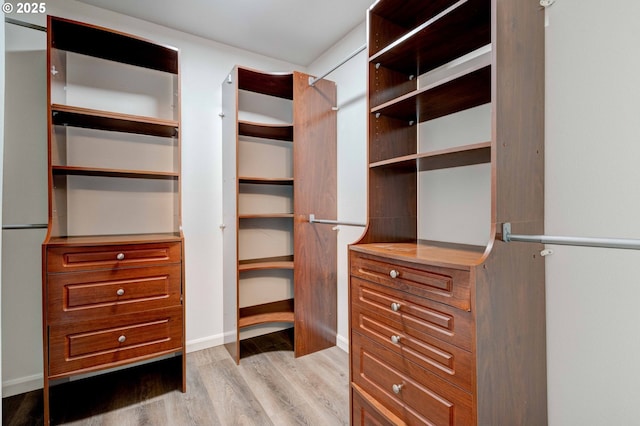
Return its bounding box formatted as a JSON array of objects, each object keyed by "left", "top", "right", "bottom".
[{"left": 369, "top": 142, "right": 491, "bottom": 172}]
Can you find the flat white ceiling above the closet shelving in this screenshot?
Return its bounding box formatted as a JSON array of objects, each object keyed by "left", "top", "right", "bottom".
[{"left": 75, "top": 0, "right": 374, "bottom": 66}]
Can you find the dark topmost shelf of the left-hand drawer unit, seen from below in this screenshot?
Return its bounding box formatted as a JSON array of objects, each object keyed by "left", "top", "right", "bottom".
[{"left": 48, "top": 16, "right": 178, "bottom": 74}]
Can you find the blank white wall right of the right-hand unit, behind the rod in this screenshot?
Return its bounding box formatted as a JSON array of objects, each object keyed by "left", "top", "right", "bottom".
[{"left": 545, "top": 0, "right": 640, "bottom": 426}]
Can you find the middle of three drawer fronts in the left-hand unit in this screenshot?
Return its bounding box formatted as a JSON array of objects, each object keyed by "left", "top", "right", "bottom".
[{"left": 47, "top": 264, "right": 182, "bottom": 324}]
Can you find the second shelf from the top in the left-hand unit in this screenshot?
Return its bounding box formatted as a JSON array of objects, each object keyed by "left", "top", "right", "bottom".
[{"left": 51, "top": 104, "right": 179, "bottom": 138}]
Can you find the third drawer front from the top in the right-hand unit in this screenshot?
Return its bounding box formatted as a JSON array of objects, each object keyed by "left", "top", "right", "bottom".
[{"left": 351, "top": 278, "right": 473, "bottom": 392}]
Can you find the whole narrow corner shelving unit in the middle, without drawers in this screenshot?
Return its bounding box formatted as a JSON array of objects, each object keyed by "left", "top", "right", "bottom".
[{"left": 222, "top": 66, "right": 337, "bottom": 363}]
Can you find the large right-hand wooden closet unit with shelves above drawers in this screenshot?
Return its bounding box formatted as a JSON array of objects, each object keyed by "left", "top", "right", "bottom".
[{"left": 349, "top": 0, "right": 547, "bottom": 425}]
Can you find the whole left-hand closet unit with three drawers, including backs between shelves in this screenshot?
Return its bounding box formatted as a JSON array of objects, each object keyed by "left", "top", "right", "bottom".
[{"left": 42, "top": 16, "right": 186, "bottom": 424}]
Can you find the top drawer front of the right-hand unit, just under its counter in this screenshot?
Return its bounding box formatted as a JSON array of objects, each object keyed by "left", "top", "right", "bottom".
[{"left": 350, "top": 251, "right": 471, "bottom": 311}]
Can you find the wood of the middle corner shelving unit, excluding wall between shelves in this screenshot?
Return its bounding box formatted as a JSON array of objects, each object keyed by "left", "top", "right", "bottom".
[{"left": 222, "top": 67, "right": 337, "bottom": 363}]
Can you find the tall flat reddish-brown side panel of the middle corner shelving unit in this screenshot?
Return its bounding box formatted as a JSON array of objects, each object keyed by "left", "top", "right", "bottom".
[{"left": 293, "top": 72, "right": 337, "bottom": 356}]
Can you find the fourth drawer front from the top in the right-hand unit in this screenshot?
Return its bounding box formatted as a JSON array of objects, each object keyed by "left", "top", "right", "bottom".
[{"left": 351, "top": 332, "right": 473, "bottom": 426}]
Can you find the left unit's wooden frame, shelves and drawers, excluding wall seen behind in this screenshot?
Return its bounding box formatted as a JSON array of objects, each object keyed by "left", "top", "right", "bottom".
[{"left": 42, "top": 16, "right": 186, "bottom": 425}]
